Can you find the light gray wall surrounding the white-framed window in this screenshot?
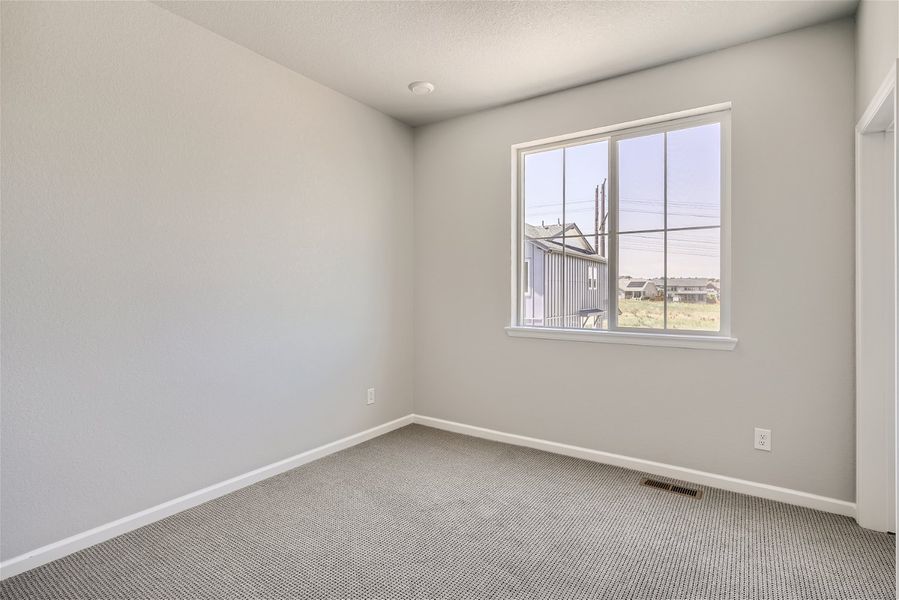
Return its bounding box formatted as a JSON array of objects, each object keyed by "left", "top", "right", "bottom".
[{"left": 415, "top": 19, "right": 855, "bottom": 500}]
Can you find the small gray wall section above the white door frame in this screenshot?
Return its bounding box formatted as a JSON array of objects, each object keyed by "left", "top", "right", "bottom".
[{"left": 855, "top": 0, "right": 899, "bottom": 119}]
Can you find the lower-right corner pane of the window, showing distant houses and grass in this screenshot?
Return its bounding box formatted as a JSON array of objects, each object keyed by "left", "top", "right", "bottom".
[{"left": 668, "top": 227, "right": 721, "bottom": 331}]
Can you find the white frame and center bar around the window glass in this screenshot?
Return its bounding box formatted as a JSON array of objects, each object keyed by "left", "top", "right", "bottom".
[{"left": 506, "top": 102, "right": 737, "bottom": 350}]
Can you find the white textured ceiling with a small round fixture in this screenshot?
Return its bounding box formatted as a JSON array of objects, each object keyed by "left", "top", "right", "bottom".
[{"left": 157, "top": 0, "right": 858, "bottom": 125}]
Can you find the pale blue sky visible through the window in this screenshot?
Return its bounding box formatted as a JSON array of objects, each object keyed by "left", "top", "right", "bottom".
[{"left": 524, "top": 123, "right": 721, "bottom": 279}]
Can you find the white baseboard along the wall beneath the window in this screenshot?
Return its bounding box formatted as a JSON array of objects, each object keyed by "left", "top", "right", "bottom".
[{"left": 414, "top": 415, "right": 855, "bottom": 518}]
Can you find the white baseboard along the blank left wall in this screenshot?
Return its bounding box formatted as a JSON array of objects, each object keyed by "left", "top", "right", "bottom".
[{"left": 0, "top": 415, "right": 413, "bottom": 580}]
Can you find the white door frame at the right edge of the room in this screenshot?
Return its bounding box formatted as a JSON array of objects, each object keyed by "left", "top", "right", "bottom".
[{"left": 855, "top": 61, "right": 899, "bottom": 532}]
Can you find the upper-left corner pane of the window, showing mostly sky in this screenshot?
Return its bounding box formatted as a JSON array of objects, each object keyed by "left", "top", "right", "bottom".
[{"left": 524, "top": 148, "right": 563, "bottom": 237}]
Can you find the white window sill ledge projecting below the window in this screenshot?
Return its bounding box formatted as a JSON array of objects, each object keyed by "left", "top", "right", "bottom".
[{"left": 506, "top": 327, "right": 737, "bottom": 350}]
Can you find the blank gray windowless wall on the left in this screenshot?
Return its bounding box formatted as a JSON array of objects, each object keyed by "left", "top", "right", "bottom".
[{"left": 0, "top": 2, "right": 412, "bottom": 559}]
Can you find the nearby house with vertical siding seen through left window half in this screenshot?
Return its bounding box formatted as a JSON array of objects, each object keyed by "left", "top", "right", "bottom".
[{"left": 522, "top": 223, "right": 609, "bottom": 329}]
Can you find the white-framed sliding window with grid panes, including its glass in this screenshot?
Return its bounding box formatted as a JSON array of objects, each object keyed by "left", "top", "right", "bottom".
[{"left": 509, "top": 105, "right": 736, "bottom": 348}]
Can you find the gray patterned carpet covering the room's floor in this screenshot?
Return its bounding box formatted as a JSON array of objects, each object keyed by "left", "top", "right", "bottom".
[{"left": 0, "top": 425, "right": 895, "bottom": 600}]
